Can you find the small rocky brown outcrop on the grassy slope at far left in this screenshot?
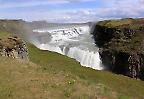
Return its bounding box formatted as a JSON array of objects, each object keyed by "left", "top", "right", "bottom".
[{"left": 0, "top": 37, "right": 28, "bottom": 60}]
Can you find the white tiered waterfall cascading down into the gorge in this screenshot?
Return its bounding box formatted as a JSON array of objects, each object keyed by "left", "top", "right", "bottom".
[{"left": 32, "top": 24, "right": 104, "bottom": 70}]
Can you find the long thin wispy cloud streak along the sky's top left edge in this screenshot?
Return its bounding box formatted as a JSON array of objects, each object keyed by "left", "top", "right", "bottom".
[{"left": 0, "top": 0, "right": 94, "bottom": 8}]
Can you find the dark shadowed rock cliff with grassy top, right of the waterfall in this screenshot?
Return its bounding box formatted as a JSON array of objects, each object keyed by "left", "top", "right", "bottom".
[{"left": 93, "top": 19, "right": 144, "bottom": 79}]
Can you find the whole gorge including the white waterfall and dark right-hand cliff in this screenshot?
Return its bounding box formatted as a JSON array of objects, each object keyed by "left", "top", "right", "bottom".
[{"left": 0, "top": 18, "right": 144, "bottom": 79}]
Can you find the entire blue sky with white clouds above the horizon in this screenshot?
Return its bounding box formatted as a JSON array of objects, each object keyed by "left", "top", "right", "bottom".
[{"left": 0, "top": 0, "right": 144, "bottom": 23}]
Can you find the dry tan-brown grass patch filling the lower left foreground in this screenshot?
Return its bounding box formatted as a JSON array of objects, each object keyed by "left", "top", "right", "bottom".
[{"left": 0, "top": 57, "right": 117, "bottom": 99}]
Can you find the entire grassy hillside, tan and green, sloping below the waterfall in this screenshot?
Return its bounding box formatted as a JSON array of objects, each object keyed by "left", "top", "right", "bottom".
[{"left": 0, "top": 19, "right": 144, "bottom": 99}]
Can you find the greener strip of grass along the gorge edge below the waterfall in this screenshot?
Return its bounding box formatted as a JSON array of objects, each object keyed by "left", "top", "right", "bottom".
[{"left": 29, "top": 45, "right": 144, "bottom": 99}]
